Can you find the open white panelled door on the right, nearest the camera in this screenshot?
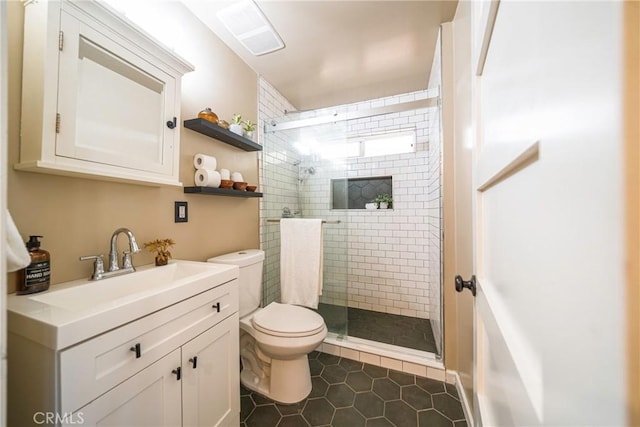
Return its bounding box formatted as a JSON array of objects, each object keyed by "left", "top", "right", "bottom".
[{"left": 472, "top": 1, "right": 626, "bottom": 426}]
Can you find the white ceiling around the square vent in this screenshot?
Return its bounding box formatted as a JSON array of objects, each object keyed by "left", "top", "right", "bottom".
[{"left": 183, "top": 0, "right": 457, "bottom": 110}]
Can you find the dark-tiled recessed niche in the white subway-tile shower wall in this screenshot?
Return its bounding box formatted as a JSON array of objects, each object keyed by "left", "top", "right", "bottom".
[{"left": 331, "top": 176, "right": 393, "bottom": 209}]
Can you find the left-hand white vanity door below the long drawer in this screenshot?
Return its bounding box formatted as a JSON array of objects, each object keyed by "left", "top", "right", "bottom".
[{"left": 67, "top": 349, "right": 181, "bottom": 427}]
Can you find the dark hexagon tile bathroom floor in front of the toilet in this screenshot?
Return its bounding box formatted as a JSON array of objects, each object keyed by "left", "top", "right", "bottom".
[{"left": 240, "top": 351, "right": 467, "bottom": 427}]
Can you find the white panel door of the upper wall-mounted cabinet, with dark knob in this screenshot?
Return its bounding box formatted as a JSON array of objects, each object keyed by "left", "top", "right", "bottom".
[{"left": 55, "top": 11, "right": 179, "bottom": 175}]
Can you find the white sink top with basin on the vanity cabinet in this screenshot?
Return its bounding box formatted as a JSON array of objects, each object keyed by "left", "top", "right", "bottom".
[{"left": 7, "top": 260, "right": 239, "bottom": 350}]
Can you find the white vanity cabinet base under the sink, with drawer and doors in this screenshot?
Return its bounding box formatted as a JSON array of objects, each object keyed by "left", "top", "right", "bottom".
[{"left": 9, "top": 280, "right": 240, "bottom": 427}]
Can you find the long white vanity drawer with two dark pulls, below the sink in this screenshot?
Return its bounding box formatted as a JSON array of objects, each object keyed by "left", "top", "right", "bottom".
[{"left": 60, "top": 280, "right": 238, "bottom": 412}]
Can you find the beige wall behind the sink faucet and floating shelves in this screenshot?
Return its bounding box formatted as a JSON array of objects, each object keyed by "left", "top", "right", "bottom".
[{"left": 7, "top": 1, "right": 259, "bottom": 292}]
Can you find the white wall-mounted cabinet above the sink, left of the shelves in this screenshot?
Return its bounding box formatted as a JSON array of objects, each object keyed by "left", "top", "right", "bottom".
[{"left": 15, "top": 0, "right": 193, "bottom": 185}]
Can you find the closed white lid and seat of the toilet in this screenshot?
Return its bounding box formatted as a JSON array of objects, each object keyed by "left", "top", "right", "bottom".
[{"left": 253, "top": 302, "right": 325, "bottom": 337}]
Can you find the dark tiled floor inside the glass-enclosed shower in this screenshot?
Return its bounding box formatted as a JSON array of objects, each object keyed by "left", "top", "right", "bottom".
[{"left": 318, "top": 304, "right": 436, "bottom": 353}]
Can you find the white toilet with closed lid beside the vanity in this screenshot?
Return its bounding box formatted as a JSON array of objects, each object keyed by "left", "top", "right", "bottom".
[{"left": 207, "top": 249, "right": 327, "bottom": 404}]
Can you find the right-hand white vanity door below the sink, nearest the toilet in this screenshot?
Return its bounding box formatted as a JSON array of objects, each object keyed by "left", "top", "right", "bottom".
[{"left": 182, "top": 313, "right": 240, "bottom": 427}]
